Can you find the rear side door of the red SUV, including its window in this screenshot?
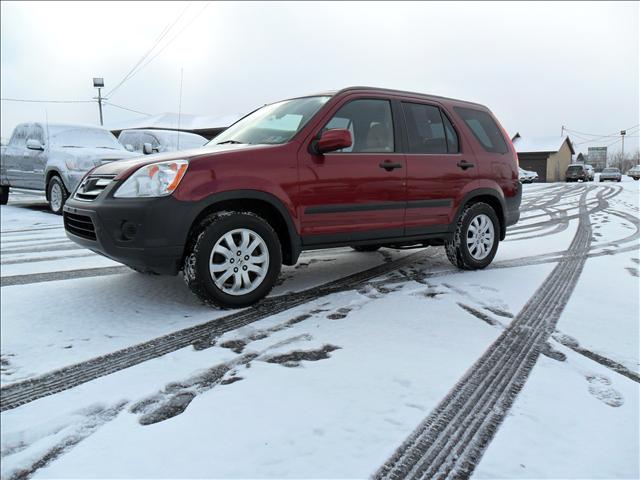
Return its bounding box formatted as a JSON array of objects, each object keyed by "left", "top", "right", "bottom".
[{"left": 401, "top": 100, "right": 477, "bottom": 236}]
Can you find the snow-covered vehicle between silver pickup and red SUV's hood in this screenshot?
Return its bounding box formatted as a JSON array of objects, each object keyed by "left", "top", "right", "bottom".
[{"left": 118, "top": 129, "right": 208, "bottom": 155}]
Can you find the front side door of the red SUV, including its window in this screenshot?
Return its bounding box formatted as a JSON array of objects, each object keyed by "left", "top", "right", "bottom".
[{"left": 298, "top": 97, "right": 406, "bottom": 245}]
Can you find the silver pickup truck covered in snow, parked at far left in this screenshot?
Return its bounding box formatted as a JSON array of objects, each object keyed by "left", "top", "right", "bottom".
[{"left": 0, "top": 122, "right": 138, "bottom": 213}]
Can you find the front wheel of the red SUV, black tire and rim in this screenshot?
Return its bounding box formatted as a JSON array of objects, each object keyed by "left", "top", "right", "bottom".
[{"left": 183, "top": 212, "right": 282, "bottom": 308}]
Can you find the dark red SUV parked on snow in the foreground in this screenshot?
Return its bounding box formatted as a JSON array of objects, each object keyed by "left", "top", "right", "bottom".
[{"left": 64, "top": 87, "right": 522, "bottom": 307}]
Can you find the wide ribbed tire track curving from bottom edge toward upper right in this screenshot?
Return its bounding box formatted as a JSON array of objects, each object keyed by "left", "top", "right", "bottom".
[{"left": 374, "top": 189, "right": 591, "bottom": 479}]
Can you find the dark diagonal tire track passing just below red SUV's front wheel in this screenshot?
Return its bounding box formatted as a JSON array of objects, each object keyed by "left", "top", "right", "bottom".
[{"left": 0, "top": 249, "right": 441, "bottom": 411}]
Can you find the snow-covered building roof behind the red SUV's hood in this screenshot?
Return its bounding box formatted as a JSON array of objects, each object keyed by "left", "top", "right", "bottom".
[{"left": 107, "top": 113, "right": 241, "bottom": 140}]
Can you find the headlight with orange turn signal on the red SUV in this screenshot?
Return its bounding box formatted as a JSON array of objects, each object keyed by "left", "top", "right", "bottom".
[{"left": 113, "top": 160, "right": 189, "bottom": 198}]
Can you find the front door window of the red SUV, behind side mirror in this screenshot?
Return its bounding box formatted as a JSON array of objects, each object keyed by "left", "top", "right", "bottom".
[{"left": 324, "top": 99, "right": 395, "bottom": 153}]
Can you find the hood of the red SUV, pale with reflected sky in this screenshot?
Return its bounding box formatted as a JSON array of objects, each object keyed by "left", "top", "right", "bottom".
[{"left": 91, "top": 144, "right": 270, "bottom": 178}]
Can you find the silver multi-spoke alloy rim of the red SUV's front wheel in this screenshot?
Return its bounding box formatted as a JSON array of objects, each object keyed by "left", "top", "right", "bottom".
[{"left": 209, "top": 228, "right": 269, "bottom": 296}]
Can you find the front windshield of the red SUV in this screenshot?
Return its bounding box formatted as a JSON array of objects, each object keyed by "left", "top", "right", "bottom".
[{"left": 207, "top": 97, "right": 330, "bottom": 145}]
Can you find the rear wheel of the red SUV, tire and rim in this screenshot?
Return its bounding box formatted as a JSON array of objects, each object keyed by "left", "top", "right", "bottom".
[{"left": 445, "top": 202, "right": 500, "bottom": 270}]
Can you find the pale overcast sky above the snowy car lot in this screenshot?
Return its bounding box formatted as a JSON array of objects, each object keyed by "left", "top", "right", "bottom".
[{"left": 0, "top": 2, "right": 640, "bottom": 152}]
